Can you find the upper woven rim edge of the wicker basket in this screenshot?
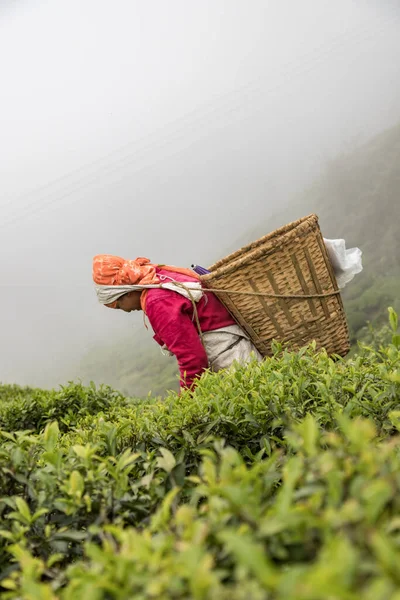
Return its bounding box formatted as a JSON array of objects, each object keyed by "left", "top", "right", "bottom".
[{"left": 205, "top": 213, "right": 322, "bottom": 282}]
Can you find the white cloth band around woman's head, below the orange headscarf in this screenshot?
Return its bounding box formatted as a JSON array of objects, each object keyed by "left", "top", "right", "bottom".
[{"left": 95, "top": 281, "right": 203, "bottom": 304}]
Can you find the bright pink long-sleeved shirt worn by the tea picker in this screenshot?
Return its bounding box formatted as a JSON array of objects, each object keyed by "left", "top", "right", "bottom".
[{"left": 146, "top": 269, "right": 235, "bottom": 388}]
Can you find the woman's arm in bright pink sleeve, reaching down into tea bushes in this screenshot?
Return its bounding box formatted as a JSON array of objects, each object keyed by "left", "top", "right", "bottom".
[{"left": 146, "top": 290, "right": 208, "bottom": 388}]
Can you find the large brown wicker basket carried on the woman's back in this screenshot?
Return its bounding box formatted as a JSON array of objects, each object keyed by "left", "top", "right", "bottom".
[{"left": 201, "top": 215, "right": 350, "bottom": 356}]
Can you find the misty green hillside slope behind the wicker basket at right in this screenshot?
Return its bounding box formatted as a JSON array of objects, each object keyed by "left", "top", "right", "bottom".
[{"left": 228, "top": 124, "right": 400, "bottom": 343}]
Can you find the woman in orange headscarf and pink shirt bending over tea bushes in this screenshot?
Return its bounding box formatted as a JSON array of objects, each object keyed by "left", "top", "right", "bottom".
[{"left": 93, "top": 254, "right": 262, "bottom": 388}]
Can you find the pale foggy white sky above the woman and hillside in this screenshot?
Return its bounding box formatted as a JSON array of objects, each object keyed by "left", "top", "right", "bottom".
[{"left": 0, "top": 0, "right": 400, "bottom": 384}]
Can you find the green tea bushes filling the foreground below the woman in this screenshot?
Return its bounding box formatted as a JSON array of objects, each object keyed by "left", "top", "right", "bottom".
[{"left": 0, "top": 310, "right": 400, "bottom": 600}]
